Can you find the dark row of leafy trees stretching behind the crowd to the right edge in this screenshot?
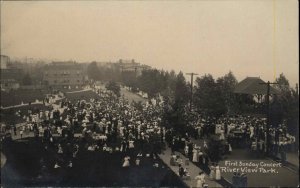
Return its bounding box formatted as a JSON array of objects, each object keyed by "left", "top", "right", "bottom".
[{"left": 88, "top": 63, "right": 299, "bottom": 128}]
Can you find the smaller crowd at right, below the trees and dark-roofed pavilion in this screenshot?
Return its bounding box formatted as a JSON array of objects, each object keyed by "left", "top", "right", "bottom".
[{"left": 177, "top": 111, "right": 296, "bottom": 162}]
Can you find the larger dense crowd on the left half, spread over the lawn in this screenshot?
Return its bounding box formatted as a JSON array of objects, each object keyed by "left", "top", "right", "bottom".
[{"left": 4, "top": 89, "right": 166, "bottom": 173}]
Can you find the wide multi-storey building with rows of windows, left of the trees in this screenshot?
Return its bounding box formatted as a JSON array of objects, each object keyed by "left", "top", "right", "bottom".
[{"left": 43, "top": 61, "right": 85, "bottom": 89}]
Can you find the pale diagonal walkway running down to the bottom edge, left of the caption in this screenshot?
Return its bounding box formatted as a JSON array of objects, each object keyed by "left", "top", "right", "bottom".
[{"left": 159, "top": 147, "right": 222, "bottom": 187}]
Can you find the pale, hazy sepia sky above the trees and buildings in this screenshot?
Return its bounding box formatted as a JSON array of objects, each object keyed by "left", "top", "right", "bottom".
[{"left": 1, "top": 0, "right": 299, "bottom": 86}]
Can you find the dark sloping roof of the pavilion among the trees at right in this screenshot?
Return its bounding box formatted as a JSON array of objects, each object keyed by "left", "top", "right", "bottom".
[{"left": 234, "top": 77, "right": 279, "bottom": 95}]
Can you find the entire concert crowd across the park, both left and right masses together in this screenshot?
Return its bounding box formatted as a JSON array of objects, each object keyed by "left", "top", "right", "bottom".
[{"left": 1, "top": 85, "right": 295, "bottom": 187}]
